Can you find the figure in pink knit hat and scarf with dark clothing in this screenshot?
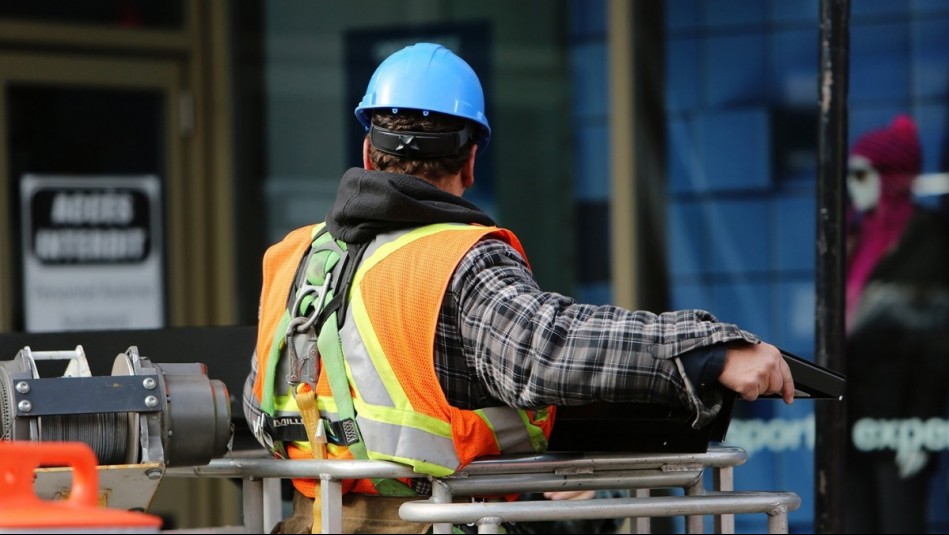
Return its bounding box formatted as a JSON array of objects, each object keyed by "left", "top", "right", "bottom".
[{"left": 845, "top": 115, "right": 949, "bottom": 533}]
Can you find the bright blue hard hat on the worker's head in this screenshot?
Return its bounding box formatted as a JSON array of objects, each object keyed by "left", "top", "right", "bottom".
[{"left": 356, "top": 43, "right": 491, "bottom": 151}]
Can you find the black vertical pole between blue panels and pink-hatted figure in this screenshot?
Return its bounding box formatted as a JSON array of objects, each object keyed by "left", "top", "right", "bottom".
[{"left": 814, "top": 0, "right": 850, "bottom": 533}]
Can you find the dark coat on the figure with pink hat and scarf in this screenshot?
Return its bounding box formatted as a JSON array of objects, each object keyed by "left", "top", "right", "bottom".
[{"left": 846, "top": 209, "right": 949, "bottom": 425}]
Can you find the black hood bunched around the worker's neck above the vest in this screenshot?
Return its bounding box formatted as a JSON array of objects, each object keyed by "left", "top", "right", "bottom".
[{"left": 326, "top": 167, "right": 495, "bottom": 243}]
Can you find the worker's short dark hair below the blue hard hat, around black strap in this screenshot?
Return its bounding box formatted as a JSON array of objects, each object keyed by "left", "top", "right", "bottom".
[{"left": 369, "top": 110, "right": 474, "bottom": 180}]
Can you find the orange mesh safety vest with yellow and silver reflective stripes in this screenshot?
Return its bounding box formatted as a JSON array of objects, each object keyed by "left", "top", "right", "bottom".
[{"left": 254, "top": 224, "right": 555, "bottom": 496}]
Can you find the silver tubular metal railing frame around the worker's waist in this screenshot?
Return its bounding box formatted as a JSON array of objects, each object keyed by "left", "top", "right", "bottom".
[{"left": 165, "top": 447, "right": 801, "bottom": 533}]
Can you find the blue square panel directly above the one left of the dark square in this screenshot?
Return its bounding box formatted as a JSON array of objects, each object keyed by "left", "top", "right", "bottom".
[{"left": 704, "top": 32, "right": 767, "bottom": 107}]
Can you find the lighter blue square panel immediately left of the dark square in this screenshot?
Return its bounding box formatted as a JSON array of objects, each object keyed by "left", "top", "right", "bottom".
[{"left": 698, "top": 109, "right": 771, "bottom": 191}]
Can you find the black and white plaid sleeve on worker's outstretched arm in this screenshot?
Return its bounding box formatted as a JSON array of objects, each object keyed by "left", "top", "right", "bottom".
[{"left": 449, "top": 239, "right": 757, "bottom": 413}]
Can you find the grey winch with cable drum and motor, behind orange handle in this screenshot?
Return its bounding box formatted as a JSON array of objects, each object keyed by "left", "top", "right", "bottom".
[{"left": 0, "top": 345, "right": 234, "bottom": 510}]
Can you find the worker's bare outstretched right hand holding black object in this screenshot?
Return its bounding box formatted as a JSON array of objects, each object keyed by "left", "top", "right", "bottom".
[{"left": 718, "top": 342, "right": 794, "bottom": 405}]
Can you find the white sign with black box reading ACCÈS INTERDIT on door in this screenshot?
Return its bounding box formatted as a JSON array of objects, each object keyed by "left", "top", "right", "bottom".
[{"left": 20, "top": 175, "right": 165, "bottom": 332}]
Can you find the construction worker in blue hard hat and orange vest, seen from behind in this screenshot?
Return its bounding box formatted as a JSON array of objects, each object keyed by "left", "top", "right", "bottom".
[{"left": 244, "top": 43, "right": 794, "bottom": 533}]
